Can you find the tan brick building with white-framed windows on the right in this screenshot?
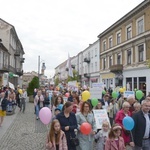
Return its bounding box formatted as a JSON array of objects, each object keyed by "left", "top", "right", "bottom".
[{"left": 98, "top": 0, "right": 150, "bottom": 94}]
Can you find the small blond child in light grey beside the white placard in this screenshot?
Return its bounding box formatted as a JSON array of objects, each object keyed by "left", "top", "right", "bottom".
[{"left": 94, "top": 121, "right": 109, "bottom": 150}]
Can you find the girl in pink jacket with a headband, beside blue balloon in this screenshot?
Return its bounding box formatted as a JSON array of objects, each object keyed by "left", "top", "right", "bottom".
[{"left": 105, "top": 124, "right": 126, "bottom": 150}]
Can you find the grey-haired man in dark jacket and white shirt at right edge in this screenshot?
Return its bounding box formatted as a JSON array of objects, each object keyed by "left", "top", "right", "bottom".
[{"left": 132, "top": 100, "right": 150, "bottom": 150}]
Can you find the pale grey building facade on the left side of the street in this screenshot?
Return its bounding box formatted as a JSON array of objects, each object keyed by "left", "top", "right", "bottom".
[{"left": 0, "top": 19, "right": 25, "bottom": 86}]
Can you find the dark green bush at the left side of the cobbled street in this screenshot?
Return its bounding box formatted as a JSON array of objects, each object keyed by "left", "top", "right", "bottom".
[{"left": 27, "top": 77, "right": 39, "bottom": 96}]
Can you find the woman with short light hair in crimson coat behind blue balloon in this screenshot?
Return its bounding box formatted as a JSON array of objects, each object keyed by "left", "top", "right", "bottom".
[{"left": 115, "top": 102, "right": 132, "bottom": 147}]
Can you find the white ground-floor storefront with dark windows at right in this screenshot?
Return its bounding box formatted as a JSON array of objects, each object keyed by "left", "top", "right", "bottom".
[{"left": 123, "top": 68, "right": 150, "bottom": 95}]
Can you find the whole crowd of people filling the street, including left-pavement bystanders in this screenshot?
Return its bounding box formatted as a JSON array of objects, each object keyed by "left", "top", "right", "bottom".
[{"left": 0, "top": 85, "right": 150, "bottom": 150}]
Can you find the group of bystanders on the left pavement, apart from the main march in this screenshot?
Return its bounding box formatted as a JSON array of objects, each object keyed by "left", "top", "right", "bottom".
[{"left": 0, "top": 86, "right": 27, "bottom": 127}]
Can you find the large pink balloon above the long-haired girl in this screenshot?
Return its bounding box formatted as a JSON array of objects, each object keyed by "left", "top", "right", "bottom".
[{"left": 39, "top": 107, "right": 52, "bottom": 125}]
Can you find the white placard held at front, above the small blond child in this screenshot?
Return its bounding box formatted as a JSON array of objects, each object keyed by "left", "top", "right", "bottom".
[{"left": 93, "top": 109, "right": 111, "bottom": 129}]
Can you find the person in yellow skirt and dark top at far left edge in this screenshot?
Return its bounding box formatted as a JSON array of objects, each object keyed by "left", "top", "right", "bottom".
[{"left": 0, "top": 92, "right": 7, "bottom": 127}]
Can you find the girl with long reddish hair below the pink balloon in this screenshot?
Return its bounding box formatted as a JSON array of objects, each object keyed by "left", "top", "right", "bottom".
[{"left": 46, "top": 119, "right": 68, "bottom": 150}]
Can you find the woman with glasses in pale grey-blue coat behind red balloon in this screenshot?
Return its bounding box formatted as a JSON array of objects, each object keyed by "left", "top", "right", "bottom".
[{"left": 76, "top": 101, "right": 96, "bottom": 150}]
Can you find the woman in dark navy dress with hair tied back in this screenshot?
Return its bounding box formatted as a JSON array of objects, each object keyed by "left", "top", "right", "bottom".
[{"left": 56, "top": 101, "right": 77, "bottom": 150}]
